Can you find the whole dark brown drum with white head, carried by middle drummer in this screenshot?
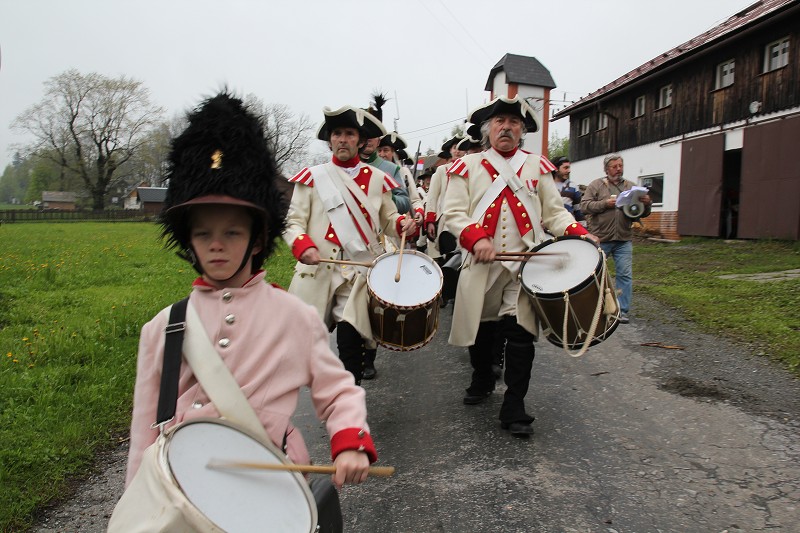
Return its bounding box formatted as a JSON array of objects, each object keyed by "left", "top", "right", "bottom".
[{"left": 367, "top": 250, "right": 442, "bottom": 351}]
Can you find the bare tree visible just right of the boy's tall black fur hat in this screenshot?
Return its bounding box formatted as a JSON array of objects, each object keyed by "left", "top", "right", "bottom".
[{"left": 245, "top": 94, "right": 313, "bottom": 174}]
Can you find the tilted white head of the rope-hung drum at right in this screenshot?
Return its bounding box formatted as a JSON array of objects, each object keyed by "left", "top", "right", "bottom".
[{"left": 520, "top": 239, "right": 600, "bottom": 294}]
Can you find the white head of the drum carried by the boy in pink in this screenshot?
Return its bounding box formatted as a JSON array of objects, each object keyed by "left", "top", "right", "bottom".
[{"left": 167, "top": 422, "right": 316, "bottom": 533}]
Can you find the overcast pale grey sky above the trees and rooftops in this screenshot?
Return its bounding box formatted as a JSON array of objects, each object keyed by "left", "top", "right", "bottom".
[{"left": 0, "top": 0, "right": 755, "bottom": 172}]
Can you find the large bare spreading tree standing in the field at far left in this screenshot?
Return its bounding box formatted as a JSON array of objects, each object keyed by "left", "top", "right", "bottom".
[{"left": 12, "top": 69, "right": 162, "bottom": 210}]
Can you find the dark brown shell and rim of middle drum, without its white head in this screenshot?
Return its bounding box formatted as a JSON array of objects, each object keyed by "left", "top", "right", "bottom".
[{"left": 367, "top": 250, "right": 443, "bottom": 351}]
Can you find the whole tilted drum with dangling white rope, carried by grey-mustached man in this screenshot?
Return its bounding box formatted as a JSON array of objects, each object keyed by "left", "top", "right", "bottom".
[{"left": 519, "top": 236, "right": 619, "bottom": 350}]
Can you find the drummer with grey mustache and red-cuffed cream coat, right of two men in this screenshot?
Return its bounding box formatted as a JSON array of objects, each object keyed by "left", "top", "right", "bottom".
[{"left": 444, "top": 96, "right": 594, "bottom": 437}]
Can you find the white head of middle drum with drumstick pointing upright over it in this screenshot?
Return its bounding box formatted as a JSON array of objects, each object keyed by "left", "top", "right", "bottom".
[{"left": 367, "top": 250, "right": 442, "bottom": 307}]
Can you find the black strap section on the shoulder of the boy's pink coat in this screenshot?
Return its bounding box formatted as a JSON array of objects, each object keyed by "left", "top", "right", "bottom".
[{"left": 156, "top": 296, "right": 189, "bottom": 425}]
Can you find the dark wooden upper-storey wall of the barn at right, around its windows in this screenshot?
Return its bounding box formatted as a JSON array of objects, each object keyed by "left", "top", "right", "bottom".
[{"left": 570, "top": 6, "right": 800, "bottom": 161}]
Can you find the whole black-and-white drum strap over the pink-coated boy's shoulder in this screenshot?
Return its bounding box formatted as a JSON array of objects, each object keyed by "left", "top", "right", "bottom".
[{"left": 154, "top": 298, "right": 269, "bottom": 441}]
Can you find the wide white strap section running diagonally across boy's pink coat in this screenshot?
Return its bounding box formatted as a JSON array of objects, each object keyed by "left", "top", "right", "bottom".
[{"left": 183, "top": 302, "right": 270, "bottom": 441}]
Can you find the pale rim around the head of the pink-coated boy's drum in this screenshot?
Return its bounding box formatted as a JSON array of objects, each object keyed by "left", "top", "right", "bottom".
[{"left": 158, "top": 417, "right": 319, "bottom": 533}]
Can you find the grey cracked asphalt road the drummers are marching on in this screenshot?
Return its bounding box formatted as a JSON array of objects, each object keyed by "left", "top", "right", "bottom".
[{"left": 35, "top": 300, "right": 800, "bottom": 533}]
